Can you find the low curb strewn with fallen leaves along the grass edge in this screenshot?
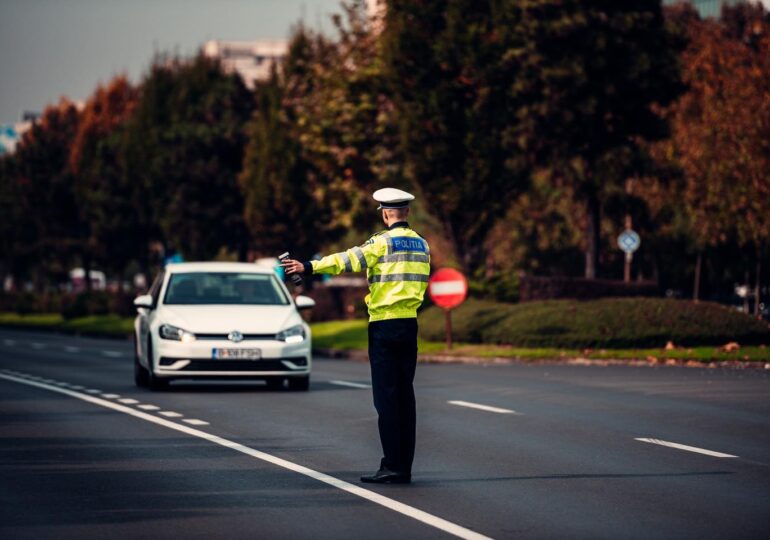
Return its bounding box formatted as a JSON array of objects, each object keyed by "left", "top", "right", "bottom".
[{"left": 313, "top": 349, "right": 770, "bottom": 370}]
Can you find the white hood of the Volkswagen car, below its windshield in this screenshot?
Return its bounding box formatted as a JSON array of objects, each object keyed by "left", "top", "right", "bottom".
[{"left": 156, "top": 306, "right": 302, "bottom": 334}]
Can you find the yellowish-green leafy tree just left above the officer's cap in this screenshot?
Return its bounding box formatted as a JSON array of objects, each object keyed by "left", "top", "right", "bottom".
[{"left": 286, "top": 0, "right": 404, "bottom": 235}]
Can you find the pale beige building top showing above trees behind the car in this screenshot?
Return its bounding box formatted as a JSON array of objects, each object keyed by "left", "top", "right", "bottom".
[{"left": 202, "top": 39, "right": 289, "bottom": 90}]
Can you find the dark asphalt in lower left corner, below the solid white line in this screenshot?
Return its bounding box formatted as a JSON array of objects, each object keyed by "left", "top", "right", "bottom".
[{"left": 0, "top": 380, "right": 452, "bottom": 538}]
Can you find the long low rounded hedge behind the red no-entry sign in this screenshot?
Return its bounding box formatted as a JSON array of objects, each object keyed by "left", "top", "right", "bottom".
[{"left": 420, "top": 298, "right": 770, "bottom": 348}]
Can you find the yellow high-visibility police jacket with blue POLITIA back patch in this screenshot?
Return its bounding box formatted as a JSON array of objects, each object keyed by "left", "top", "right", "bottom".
[{"left": 311, "top": 227, "right": 430, "bottom": 321}]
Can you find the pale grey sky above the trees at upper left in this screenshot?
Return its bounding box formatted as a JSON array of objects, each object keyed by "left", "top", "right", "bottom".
[{"left": 0, "top": 0, "right": 340, "bottom": 120}]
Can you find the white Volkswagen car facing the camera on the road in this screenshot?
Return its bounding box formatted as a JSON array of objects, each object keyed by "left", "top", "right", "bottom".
[{"left": 134, "top": 262, "right": 315, "bottom": 390}]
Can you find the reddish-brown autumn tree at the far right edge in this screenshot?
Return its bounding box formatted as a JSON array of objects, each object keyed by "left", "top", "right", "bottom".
[{"left": 657, "top": 6, "right": 770, "bottom": 309}]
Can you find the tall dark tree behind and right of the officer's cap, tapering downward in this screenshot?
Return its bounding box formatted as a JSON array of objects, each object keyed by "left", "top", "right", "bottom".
[{"left": 382, "top": 0, "right": 526, "bottom": 273}]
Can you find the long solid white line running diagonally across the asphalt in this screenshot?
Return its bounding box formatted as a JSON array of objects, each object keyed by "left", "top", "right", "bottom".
[{"left": 0, "top": 373, "right": 491, "bottom": 540}]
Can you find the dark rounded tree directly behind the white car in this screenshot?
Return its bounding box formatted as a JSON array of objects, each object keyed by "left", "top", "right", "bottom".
[{"left": 123, "top": 55, "right": 254, "bottom": 260}]
